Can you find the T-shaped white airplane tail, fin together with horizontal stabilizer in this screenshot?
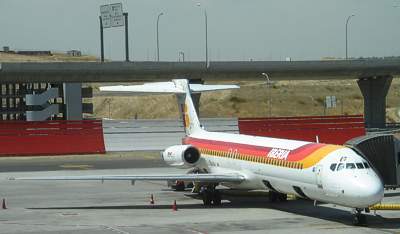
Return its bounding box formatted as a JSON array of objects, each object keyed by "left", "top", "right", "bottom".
[{"left": 100, "top": 79, "right": 239, "bottom": 135}]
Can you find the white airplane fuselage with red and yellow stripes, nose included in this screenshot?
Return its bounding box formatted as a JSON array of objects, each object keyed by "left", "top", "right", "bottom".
[{"left": 183, "top": 131, "right": 383, "bottom": 208}]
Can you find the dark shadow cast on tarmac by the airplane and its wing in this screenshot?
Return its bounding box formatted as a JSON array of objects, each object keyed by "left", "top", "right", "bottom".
[{"left": 27, "top": 197, "right": 400, "bottom": 229}]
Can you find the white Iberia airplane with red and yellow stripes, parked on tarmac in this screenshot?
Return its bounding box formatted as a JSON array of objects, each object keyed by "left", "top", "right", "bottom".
[{"left": 13, "top": 79, "right": 383, "bottom": 224}]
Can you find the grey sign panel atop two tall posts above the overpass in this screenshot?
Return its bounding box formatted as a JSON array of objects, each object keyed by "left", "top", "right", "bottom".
[{"left": 100, "top": 3, "right": 124, "bottom": 28}]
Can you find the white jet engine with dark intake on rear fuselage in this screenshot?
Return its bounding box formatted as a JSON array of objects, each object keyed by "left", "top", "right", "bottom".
[{"left": 161, "top": 145, "right": 200, "bottom": 168}]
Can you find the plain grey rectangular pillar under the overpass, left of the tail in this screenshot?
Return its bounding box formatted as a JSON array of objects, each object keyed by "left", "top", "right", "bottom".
[{"left": 63, "top": 83, "right": 82, "bottom": 120}]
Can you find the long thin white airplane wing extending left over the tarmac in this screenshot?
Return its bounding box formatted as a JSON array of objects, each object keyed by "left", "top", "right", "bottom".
[{"left": 9, "top": 173, "right": 245, "bottom": 183}]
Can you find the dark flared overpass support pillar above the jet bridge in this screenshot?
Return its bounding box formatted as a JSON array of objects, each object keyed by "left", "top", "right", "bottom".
[{"left": 357, "top": 76, "right": 393, "bottom": 128}]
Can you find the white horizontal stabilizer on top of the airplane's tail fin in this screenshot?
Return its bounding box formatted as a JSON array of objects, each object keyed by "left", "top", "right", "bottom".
[{"left": 100, "top": 80, "right": 240, "bottom": 95}]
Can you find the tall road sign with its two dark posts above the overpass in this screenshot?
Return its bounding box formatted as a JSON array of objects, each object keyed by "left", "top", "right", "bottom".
[{"left": 100, "top": 3, "right": 129, "bottom": 62}]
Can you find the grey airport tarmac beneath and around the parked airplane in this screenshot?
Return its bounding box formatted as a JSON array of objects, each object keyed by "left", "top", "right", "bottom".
[{"left": 0, "top": 153, "right": 400, "bottom": 234}]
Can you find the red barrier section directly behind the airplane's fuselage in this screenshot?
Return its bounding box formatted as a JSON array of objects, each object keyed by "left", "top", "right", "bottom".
[{"left": 239, "top": 115, "right": 365, "bottom": 145}]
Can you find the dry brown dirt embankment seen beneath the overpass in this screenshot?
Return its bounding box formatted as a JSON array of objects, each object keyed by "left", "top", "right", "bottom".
[{"left": 93, "top": 79, "right": 400, "bottom": 122}]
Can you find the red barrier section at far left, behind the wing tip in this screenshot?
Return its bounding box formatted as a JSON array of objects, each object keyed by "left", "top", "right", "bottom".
[{"left": 0, "top": 120, "right": 105, "bottom": 156}]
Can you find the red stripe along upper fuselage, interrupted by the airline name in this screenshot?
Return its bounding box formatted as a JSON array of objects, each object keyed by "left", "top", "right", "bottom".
[{"left": 182, "top": 137, "right": 326, "bottom": 162}]
